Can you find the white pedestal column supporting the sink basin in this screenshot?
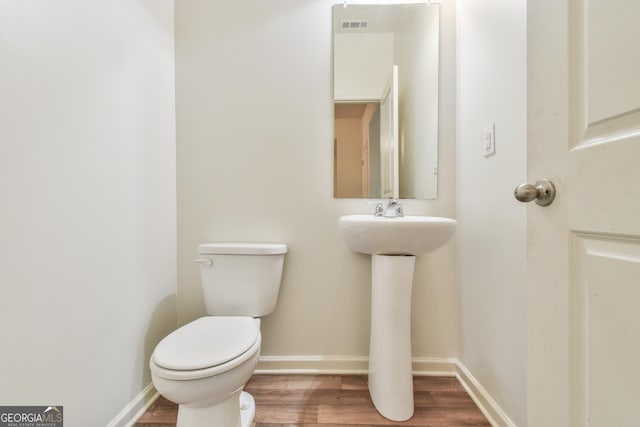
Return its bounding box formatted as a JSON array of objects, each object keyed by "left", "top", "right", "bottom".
[{"left": 369, "top": 255, "right": 416, "bottom": 421}]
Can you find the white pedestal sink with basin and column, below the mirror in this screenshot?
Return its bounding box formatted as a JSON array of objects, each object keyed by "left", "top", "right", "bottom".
[{"left": 338, "top": 215, "right": 456, "bottom": 421}]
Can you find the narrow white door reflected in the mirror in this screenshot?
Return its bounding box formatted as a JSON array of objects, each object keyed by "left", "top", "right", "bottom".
[{"left": 380, "top": 65, "right": 399, "bottom": 198}]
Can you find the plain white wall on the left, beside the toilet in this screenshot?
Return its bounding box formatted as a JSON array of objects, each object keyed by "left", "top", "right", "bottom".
[{"left": 0, "top": 0, "right": 176, "bottom": 427}]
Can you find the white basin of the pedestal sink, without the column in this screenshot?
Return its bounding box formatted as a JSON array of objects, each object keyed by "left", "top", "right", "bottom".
[{"left": 338, "top": 215, "right": 456, "bottom": 255}]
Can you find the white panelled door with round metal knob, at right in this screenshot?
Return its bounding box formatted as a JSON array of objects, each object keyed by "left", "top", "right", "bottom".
[{"left": 527, "top": 0, "right": 640, "bottom": 427}]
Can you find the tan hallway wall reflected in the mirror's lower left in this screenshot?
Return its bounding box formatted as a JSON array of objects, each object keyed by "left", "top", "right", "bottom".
[{"left": 334, "top": 118, "right": 362, "bottom": 197}]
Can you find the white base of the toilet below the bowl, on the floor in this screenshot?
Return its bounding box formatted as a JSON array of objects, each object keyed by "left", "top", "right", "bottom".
[{"left": 176, "top": 390, "right": 256, "bottom": 427}]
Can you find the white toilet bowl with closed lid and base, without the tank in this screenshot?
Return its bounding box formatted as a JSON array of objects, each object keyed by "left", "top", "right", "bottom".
[{"left": 149, "top": 316, "right": 261, "bottom": 427}]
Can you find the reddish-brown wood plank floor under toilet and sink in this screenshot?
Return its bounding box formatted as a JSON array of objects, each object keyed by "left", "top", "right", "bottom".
[{"left": 135, "top": 375, "right": 491, "bottom": 427}]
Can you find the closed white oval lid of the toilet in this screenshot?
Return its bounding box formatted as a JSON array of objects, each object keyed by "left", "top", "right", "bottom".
[{"left": 153, "top": 316, "right": 260, "bottom": 371}]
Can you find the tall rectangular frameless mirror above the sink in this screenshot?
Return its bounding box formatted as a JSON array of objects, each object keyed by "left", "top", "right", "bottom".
[{"left": 333, "top": 3, "right": 439, "bottom": 199}]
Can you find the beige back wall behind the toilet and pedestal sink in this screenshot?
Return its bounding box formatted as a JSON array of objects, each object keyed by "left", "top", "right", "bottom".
[{"left": 175, "top": 0, "right": 458, "bottom": 357}]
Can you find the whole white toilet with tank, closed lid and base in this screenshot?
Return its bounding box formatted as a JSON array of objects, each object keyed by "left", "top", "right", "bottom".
[{"left": 149, "top": 243, "right": 287, "bottom": 427}]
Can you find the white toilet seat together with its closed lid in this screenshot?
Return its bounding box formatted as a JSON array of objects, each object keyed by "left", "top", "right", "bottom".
[{"left": 149, "top": 316, "right": 261, "bottom": 380}]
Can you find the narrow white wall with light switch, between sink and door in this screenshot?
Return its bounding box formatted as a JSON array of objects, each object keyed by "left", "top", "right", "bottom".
[{"left": 457, "top": 0, "right": 528, "bottom": 426}]
